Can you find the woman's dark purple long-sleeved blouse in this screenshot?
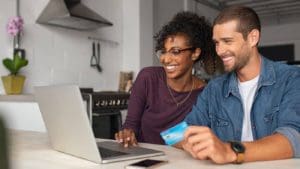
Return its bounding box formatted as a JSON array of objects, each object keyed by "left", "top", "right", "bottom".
[{"left": 122, "top": 67, "right": 203, "bottom": 144}]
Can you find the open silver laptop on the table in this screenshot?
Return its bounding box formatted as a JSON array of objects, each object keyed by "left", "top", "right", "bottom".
[{"left": 34, "top": 85, "right": 164, "bottom": 164}]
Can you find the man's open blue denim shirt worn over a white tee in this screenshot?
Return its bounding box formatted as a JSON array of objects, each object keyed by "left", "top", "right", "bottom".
[{"left": 185, "top": 57, "right": 300, "bottom": 157}]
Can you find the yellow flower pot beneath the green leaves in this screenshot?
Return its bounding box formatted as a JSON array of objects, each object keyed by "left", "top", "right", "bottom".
[{"left": 1, "top": 75, "right": 25, "bottom": 94}]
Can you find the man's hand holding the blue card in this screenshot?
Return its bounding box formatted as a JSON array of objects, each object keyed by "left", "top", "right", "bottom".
[{"left": 182, "top": 126, "right": 237, "bottom": 164}]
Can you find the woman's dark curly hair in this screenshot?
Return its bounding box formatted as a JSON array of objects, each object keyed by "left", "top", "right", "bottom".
[{"left": 154, "top": 11, "right": 217, "bottom": 74}]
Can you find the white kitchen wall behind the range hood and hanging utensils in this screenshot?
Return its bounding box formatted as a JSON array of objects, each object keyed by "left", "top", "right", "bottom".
[{"left": 0, "top": 0, "right": 123, "bottom": 93}]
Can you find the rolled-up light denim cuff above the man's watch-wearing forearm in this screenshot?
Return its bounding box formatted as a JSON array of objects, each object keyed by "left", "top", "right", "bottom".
[{"left": 274, "top": 127, "right": 300, "bottom": 158}]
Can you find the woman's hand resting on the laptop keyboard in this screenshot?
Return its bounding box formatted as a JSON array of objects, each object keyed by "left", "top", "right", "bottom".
[{"left": 115, "top": 129, "right": 137, "bottom": 147}]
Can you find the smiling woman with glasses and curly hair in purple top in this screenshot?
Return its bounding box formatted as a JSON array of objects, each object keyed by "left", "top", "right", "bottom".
[{"left": 115, "top": 12, "right": 216, "bottom": 147}]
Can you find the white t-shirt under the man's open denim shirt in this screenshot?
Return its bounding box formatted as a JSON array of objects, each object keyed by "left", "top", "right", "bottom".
[{"left": 238, "top": 76, "right": 259, "bottom": 141}]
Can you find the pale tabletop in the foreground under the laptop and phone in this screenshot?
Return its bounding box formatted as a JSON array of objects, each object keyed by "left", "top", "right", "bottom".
[{"left": 10, "top": 131, "right": 300, "bottom": 169}]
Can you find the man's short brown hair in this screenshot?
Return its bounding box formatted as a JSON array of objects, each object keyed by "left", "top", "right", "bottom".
[{"left": 213, "top": 6, "right": 261, "bottom": 40}]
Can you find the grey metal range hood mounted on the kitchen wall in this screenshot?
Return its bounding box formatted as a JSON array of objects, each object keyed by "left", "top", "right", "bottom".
[{"left": 37, "top": 0, "right": 113, "bottom": 30}]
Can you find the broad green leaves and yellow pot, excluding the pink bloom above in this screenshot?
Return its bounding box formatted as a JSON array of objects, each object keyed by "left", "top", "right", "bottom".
[{"left": 1, "top": 54, "right": 28, "bottom": 94}]
